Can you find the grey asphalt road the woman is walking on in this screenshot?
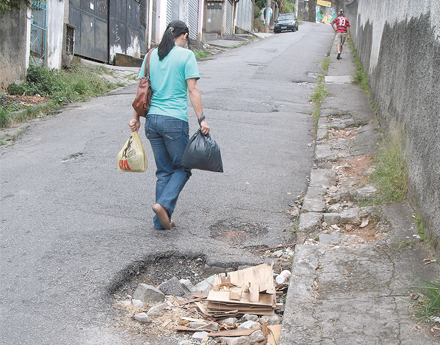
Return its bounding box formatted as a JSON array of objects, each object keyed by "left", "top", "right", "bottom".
[{"left": 0, "top": 23, "right": 333, "bottom": 344}]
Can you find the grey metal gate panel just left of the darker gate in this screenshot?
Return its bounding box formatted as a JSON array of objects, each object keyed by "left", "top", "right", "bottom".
[{"left": 69, "top": 0, "right": 109, "bottom": 62}]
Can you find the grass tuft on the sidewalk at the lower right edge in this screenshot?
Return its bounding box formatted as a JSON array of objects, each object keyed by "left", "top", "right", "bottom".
[{"left": 412, "top": 277, "right": 440, "bottom": 323}]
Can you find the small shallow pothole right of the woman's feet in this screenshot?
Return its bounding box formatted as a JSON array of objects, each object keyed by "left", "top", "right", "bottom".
[{"left": 210, "top": 219, "right": 268, "bottom": 245}]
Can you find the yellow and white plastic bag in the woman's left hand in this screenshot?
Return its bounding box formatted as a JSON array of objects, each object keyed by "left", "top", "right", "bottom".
[{"left": 118, "top": 131, "right": 148, "bottom": 172}]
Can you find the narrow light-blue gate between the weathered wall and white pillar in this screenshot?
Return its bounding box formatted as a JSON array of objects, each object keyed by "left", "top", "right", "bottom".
[{"left": 30, "top": 0, "right": 46, "bottom": 66}]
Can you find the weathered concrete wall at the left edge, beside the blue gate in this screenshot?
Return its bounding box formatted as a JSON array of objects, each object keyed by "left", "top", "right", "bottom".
[{"left": 0, "top": 8, "right": 28, "bottom": 88}]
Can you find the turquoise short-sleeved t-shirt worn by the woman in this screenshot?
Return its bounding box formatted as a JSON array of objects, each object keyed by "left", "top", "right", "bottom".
[{"left": 139, "top": 46, "right": 200, "bottom": 122}]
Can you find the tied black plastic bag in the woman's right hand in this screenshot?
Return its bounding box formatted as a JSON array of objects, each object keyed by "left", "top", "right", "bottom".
[{"left": 182, "top": 129, "right": 223, "bottom": 172}]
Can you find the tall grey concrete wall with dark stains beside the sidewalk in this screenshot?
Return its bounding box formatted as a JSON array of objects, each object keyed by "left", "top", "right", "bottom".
[{"left": 346, "top": 0, "right": 440, "bottom": 254}]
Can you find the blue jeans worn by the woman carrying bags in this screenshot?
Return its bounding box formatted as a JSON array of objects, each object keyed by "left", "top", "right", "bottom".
[{"left": 145, "top": 114, "right": 191, "bottom": 230}]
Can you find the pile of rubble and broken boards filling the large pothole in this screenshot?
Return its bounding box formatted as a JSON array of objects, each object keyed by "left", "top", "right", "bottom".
[{"left": 115, "top": 264, "right": 290, "bottom": 345}]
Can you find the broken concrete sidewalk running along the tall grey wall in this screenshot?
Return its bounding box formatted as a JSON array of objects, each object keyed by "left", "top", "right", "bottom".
[{"left": 280, "top": 45, "right": 439, "bottom": 345}]
